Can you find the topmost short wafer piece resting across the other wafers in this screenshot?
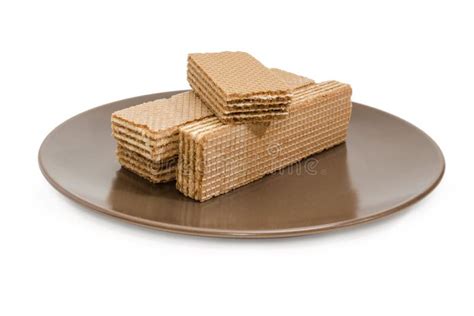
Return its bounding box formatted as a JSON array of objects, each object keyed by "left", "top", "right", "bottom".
[{"left": 188, "top": 52, "right": 291, "bottom": 124}]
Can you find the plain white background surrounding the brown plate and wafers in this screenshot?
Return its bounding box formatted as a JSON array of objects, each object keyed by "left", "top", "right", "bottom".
[{"left": 0, "top": 0, "right": 474, "bottom": 315}]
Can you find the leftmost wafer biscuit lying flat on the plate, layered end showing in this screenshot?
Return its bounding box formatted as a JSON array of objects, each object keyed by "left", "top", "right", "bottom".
[{"left": 112, "top": 91, "right": 212, "bottom": 183}]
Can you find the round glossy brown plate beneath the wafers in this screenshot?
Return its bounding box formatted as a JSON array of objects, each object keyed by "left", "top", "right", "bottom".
[{"left": 39, "top": 91, "right": 444, "bottom": 238}]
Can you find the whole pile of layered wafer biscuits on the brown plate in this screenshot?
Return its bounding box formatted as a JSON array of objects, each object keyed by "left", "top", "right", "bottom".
[{"left": 112, "top": 52, "right": 352, "bottom": 201}]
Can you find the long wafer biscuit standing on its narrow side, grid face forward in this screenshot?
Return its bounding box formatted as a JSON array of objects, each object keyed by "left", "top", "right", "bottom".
[{"left": 176, "top": 81, "right": 352, "bottom": 201}]
